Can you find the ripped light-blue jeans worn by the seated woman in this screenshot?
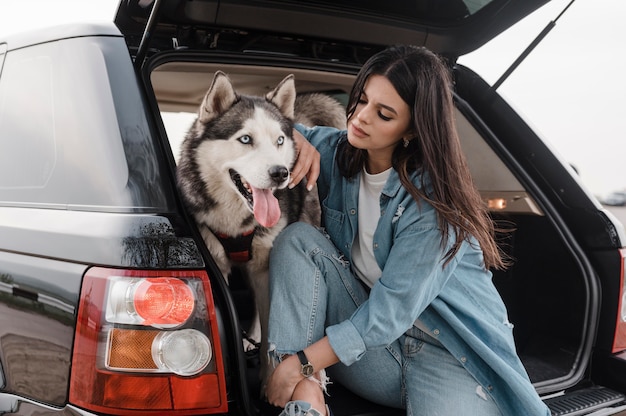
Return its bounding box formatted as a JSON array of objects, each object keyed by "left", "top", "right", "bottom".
[{"left": 268, "top": 223, "right": 501, "bottom": 416}]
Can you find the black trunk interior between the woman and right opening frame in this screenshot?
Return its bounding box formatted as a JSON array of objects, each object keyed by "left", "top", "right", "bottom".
[{"left": 494, "top": 215, "right": 590, "bottom": 391}]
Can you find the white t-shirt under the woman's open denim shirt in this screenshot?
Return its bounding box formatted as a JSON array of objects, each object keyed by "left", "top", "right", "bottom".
[{"left": 352, "top": 168, "right": 391, "bottom": 287}]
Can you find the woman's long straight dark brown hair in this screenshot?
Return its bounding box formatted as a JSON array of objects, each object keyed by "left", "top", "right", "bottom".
[{"left": 338, "top": 45, "right": 508, "bottom": 269}]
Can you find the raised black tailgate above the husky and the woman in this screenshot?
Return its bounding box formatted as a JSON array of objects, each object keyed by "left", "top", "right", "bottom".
[{"left": 115, "top": 0, "right": 549, "bottom": 59}]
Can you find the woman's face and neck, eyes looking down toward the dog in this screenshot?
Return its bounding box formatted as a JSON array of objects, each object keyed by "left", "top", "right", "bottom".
[{"left": 348, "top": 75, "right": 411, "bottom": 173}]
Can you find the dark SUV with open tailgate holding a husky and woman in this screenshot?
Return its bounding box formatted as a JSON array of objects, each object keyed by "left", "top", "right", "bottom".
[{"left": 0, "top": 0, "right": 626, "bottom": 416}]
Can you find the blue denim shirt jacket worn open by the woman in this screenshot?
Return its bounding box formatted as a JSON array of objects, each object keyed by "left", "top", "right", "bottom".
[{"left": 296, "top": 125, "right": 550, "bottom": 416}]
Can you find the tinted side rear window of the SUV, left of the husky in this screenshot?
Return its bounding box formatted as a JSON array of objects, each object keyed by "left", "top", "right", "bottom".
[{"left": 0, "top": 37, "right": 171, "bottom": 212}]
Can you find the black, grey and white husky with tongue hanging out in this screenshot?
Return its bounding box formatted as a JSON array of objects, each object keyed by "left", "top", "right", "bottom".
[{"left": 177, "top": 71, "right": 345, "bottom": 386}]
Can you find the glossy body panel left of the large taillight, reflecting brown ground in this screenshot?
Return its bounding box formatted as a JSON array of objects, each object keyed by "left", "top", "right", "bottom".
[{"left": 0, "top": 252, "right": 81, "bottom": 406}]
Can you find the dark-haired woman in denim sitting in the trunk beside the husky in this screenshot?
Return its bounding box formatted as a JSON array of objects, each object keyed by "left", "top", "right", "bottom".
[{"left": 266, "top": 46, "right": 550, "bottom": 416}]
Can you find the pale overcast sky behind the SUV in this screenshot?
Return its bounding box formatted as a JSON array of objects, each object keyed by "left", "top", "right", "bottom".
[{"left": 0, "top": 0, "right": 626, "bottom": 195}]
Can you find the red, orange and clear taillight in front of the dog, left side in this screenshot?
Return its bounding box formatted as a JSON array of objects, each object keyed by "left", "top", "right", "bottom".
[{"left": 70, "top": 268, "right": 228, "bottom": 415}]
